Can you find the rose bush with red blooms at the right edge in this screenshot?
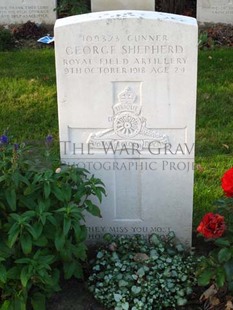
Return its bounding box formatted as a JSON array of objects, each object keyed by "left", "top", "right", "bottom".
[{"left": 197, "top": 168, "right": 233, "bottom": 291}]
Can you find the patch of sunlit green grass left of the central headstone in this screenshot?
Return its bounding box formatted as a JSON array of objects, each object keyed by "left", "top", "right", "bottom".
[{"left": 0, "top": 49, "right": 58, "bottom": 141}]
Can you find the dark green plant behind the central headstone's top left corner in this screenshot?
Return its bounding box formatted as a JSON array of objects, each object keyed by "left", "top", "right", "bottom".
[{"left": 57, "top": 0, "right": 90, "bottom": 17}]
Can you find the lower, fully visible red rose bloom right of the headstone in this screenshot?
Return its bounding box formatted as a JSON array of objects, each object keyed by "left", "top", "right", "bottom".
[{"left": 197, "top": 213, "right": 226, "bottom": 239}]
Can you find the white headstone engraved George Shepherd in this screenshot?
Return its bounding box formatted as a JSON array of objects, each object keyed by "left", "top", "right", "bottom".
[{"left": 55, "top": 11, "right": 197, "bottom": 245}]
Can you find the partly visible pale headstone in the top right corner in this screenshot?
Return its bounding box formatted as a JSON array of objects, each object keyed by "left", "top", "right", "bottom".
[{"left": 197, "top": 0, "right": 233, "bottom": 24}]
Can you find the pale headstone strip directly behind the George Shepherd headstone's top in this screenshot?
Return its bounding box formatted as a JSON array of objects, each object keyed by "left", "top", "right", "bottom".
[{"left": 91, "top": 0, "right": 155, "bottom": 12}]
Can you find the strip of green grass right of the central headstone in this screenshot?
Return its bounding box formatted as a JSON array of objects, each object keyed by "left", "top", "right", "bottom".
[{"left": 194, "top": 49, "right": 233, "bottom": 227}]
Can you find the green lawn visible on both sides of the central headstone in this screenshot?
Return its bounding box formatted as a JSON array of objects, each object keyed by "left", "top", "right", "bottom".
[{"left": 0, "top": 49, "right": 233, "bottom": 227}]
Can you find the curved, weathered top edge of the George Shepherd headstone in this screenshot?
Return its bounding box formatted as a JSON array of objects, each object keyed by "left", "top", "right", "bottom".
[{"left": 55, "top": 10, "right": 197, "bottom": 28}]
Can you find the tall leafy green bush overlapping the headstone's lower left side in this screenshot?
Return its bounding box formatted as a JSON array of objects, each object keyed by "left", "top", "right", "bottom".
[{"left": 0, "top": 135, "right": 105, "bottom": 310}]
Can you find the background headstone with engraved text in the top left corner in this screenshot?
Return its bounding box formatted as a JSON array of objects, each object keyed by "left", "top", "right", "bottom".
[{"left": 0, "top": 0, "right": 56, "bottom": 25}]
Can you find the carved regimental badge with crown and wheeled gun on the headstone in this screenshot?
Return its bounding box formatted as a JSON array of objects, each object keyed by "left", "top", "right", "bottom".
[{"left": 87, "top": 87, "right": 169, "bottom": 150}]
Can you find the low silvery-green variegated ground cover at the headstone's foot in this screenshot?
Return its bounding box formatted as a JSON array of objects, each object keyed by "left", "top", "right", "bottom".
[{"left": 89, "top": 233, "right": 197, "bottom": 310}]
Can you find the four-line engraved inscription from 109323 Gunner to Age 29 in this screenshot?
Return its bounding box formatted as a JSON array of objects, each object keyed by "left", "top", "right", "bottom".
[{"left": 62, "top": 34, "right": 188, "bottom": 76}]
